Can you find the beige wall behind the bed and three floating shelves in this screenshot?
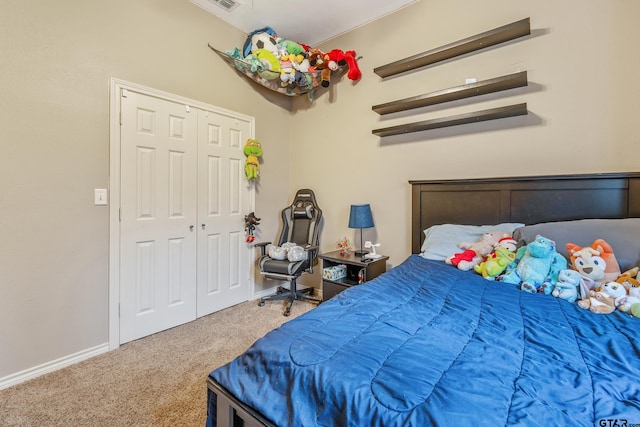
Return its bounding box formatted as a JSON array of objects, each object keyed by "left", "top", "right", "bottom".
[{"left": 291, "top": 0, "right": 640, "bottom": 265}]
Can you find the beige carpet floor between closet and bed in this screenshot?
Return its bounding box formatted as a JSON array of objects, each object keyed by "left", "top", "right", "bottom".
[{"left": 0, "top": 301, "right": 314, "bottom": 426}]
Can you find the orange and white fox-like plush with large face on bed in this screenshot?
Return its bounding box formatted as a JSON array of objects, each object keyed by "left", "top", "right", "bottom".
[{"left": 567, "top": 239, "right": 620, "bottom": 285}]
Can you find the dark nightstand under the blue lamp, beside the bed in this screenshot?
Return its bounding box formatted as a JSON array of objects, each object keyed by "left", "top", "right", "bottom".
[{"left": 318, "top": 251, "right": 389, "bottom": 301}]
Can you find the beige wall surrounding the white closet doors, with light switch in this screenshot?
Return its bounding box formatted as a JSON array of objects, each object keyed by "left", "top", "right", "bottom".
[{"left": 0, "top": 0, "right": 290, "bottom": 379}]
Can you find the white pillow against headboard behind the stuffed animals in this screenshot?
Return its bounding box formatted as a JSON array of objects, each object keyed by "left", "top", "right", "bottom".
[{"left": 420, "top": 222, "right": 524, "bottom": 261}]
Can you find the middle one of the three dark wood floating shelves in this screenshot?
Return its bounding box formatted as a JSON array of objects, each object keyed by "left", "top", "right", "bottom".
[{"left": 371, "top": 71, "right": 529, "bottom": 115}]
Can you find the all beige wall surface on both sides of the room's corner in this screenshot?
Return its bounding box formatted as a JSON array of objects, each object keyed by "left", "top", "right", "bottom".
[{"left": 0, "top": 0, "right": 640, "bottom": 379}]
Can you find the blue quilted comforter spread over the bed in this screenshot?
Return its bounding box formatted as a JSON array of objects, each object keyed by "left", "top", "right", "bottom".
[{"left": 211, "top": 255, "right": 640, "bottom": 427}]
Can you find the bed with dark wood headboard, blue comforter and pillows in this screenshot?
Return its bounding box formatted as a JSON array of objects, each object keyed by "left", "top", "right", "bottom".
[{"left": 207, "top": 173, "right": 640, "bottom": 426}]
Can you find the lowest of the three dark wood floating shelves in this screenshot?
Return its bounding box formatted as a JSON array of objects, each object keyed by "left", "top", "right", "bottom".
[{"left": 371, "top": 103, "right": 528, "bottom": 137}]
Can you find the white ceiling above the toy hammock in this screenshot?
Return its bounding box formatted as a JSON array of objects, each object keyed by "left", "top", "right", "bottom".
[{"left": 189, "top": 0, "right": 419, "bottom": 46}]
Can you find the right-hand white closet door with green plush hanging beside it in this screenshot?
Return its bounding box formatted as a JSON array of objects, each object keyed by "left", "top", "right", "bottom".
[{"left": 197, "top": 111, "right": 255, "bottom": 317}]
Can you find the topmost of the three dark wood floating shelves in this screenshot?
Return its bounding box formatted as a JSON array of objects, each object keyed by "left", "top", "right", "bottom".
[{"left": 373, "top": 18, "right": 531, "bottom": 78}]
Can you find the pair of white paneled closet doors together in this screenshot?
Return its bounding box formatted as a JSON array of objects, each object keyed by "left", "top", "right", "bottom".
[{"left": 120, "top": 90, "right": 252, "bottom": 343}]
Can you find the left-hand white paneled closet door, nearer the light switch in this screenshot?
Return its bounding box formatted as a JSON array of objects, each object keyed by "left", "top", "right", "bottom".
[{"left": 120, "top": 91, "right": 198, "bottom": 343}]
